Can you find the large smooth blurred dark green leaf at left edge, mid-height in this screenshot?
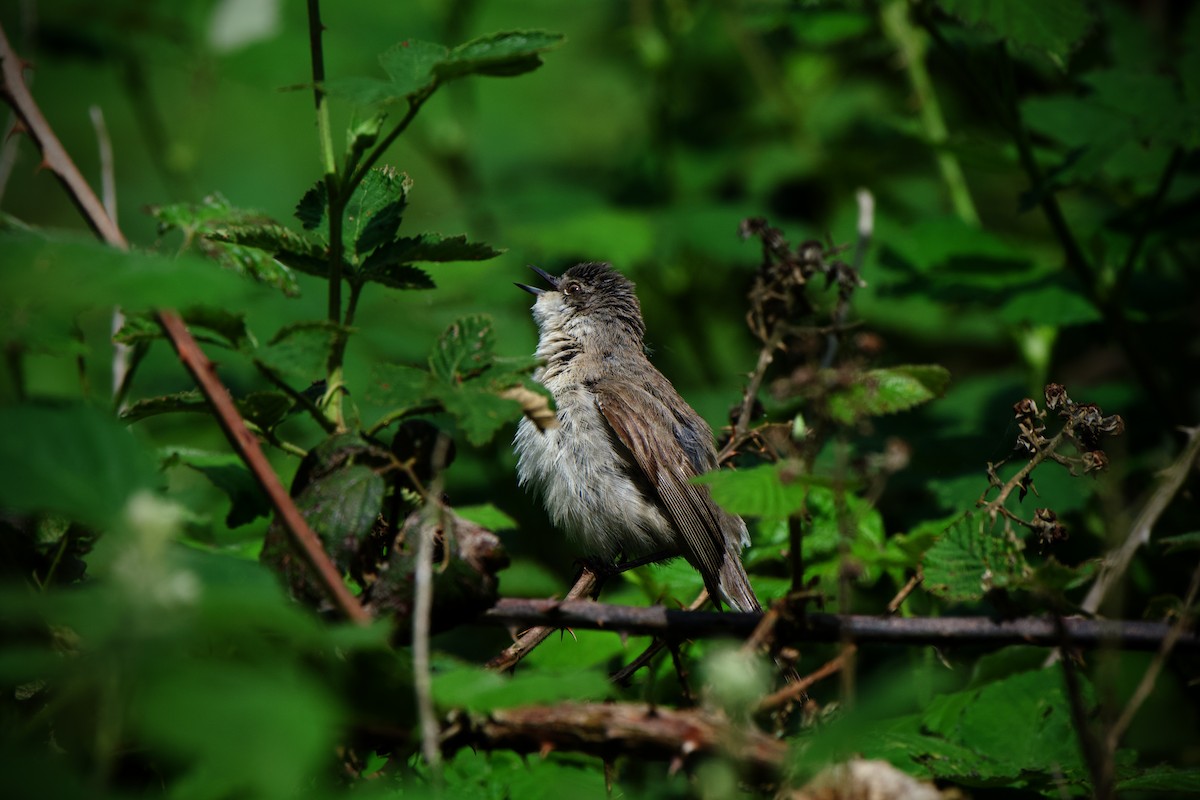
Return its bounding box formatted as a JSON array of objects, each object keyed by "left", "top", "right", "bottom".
[{"left": 0, "top": 405, "right": 157, "bottom": 528}]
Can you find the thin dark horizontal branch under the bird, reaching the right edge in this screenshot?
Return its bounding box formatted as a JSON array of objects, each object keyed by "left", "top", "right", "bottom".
[{"left": 480, "top": 597, "right": 1200, "bottom": 652}]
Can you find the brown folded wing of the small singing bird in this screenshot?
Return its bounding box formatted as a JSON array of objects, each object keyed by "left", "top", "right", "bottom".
[{"left": 594, "top": 381, "right": 726, "bottom": 604}]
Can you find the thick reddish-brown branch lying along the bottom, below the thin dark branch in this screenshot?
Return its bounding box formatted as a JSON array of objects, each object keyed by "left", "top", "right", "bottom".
[{"left": 442, "top": 703, "right": 787, "bottom": 778}]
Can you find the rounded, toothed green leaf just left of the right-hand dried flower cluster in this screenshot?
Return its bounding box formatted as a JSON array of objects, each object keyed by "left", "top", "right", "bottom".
[{"left": 923, "top": 513, "right": 1028, "bottom": 602}]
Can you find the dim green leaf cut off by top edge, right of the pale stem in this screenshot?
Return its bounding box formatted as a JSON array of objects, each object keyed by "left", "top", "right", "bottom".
[{"left": 938, "top": 0, "right": 1093, "bottom": 66}]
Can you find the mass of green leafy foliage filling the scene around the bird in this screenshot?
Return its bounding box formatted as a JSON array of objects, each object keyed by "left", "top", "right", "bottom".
[{"left": 0, "top": 0, "right": 1200, "bottom": 798}]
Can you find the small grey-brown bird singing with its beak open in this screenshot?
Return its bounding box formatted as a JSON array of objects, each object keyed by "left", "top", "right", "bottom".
[{"left": 514, "top": 263, "right": 761, "bottom": 612}]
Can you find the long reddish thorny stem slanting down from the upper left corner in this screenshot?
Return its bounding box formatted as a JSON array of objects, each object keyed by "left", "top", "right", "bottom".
[{"left": 0, "top": 21, "right": 371, "bottom": 624}]
